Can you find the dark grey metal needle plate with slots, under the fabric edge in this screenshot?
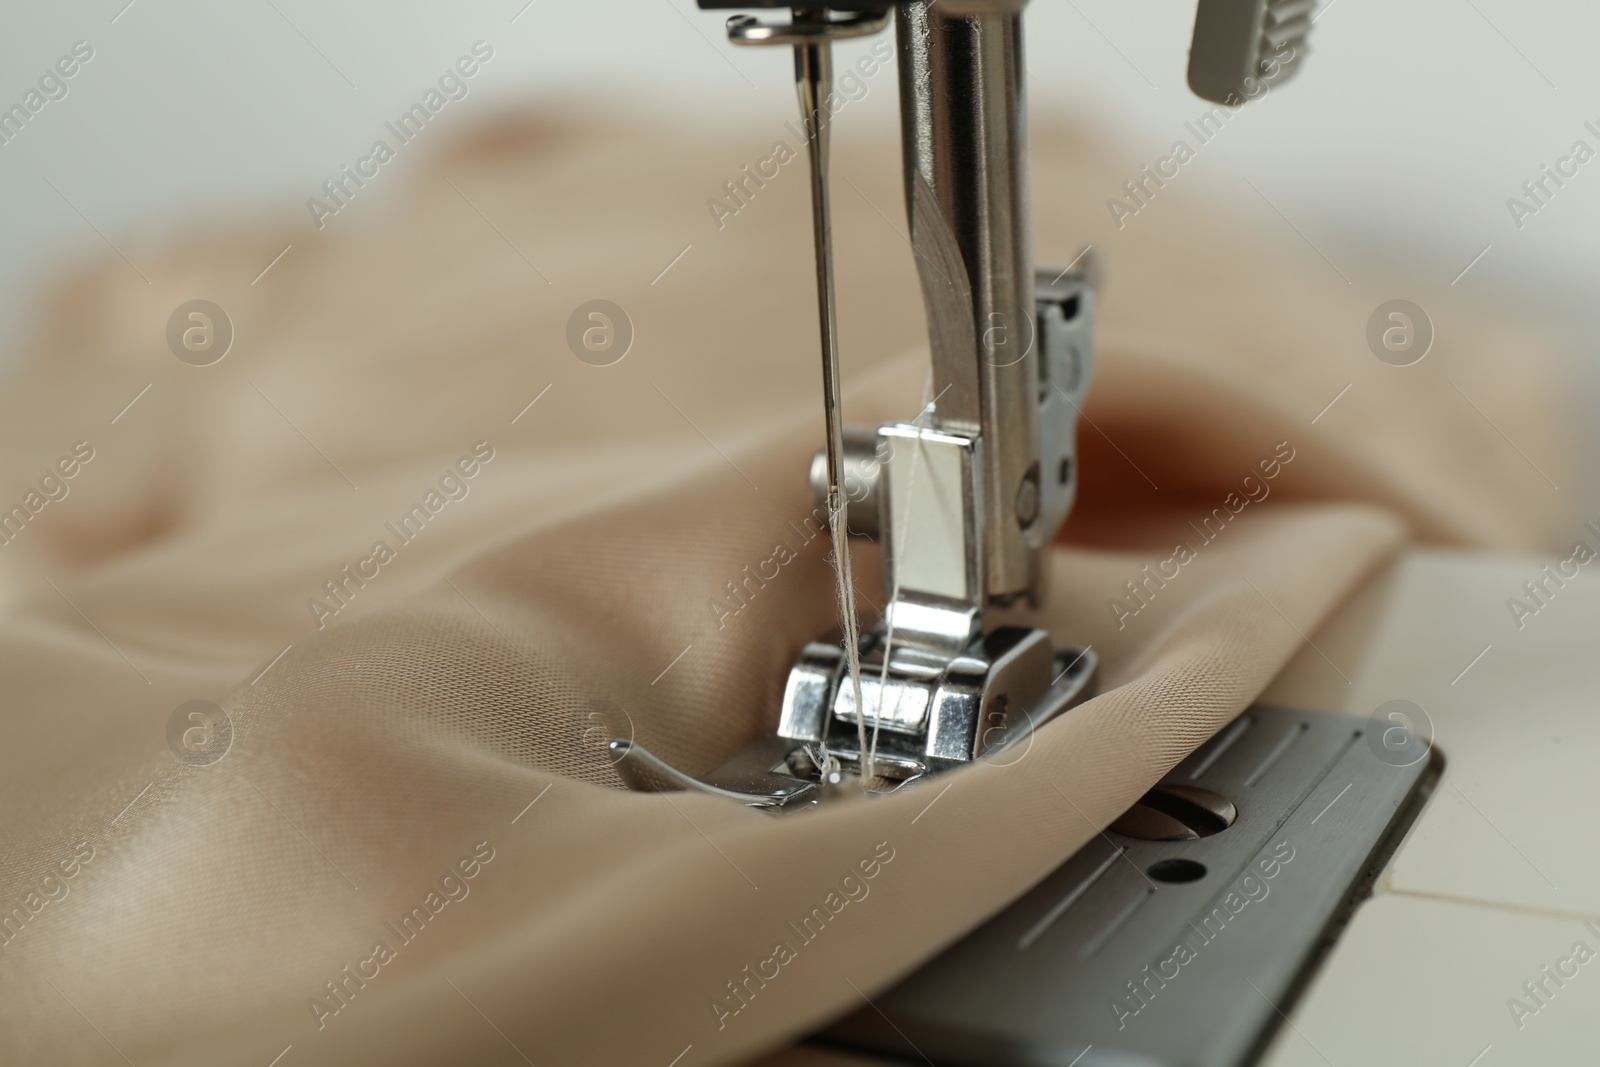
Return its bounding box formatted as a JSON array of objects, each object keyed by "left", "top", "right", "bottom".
[{"left": 818, "top": 707, "right": 1442, "bottom": 1067}]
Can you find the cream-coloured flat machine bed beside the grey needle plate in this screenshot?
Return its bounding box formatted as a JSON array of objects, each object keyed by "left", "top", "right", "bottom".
[{"left": 1262, "top": 550, "right": 1600, "bottom": 1067}]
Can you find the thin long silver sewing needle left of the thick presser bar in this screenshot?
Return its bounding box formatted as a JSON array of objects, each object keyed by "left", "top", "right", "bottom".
[{"left": 795, "top": 22, "right": 872, "bottom": 782}]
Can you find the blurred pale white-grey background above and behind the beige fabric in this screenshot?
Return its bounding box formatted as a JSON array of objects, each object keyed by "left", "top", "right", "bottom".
[{"left": 0, "top": 0, "right": 1600, "bottom": 371}]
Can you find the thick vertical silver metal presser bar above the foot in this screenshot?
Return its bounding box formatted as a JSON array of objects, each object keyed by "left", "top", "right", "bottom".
[{"left": 898, "top": 0, "right": 1042, "bottom": 601}]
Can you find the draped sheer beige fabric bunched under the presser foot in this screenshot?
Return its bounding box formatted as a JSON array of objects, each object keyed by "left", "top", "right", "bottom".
[{"left": 0, "top": 112, "right": 1566, "bottom": 1067}]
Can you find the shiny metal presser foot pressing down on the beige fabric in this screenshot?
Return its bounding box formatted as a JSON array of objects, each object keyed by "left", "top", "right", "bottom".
[{"left": 610, "top": 625, "right": 1098, "bottom": 811}]
